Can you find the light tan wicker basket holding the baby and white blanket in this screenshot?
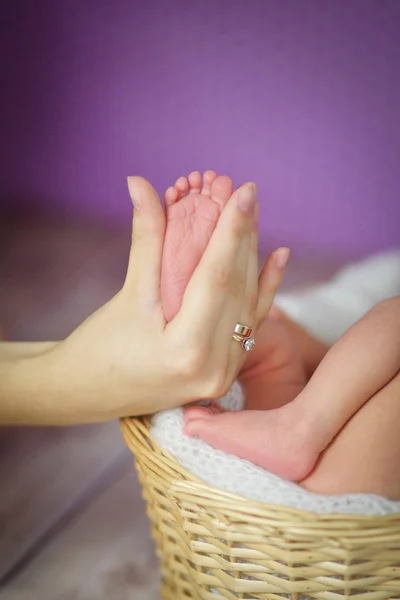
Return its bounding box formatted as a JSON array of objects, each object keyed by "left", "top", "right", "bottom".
[{"left": 122, "top": 418, "right": 400, "bottom": 600}]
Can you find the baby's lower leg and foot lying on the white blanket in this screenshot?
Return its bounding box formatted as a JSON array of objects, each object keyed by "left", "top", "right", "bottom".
[{"left": 186, "top": 299, "right": 400, "bottom": 485}]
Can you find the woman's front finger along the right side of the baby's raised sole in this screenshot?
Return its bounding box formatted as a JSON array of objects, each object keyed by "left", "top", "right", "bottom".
[{"left": 169, "top": 183, "right": 256, "bottom": 344}]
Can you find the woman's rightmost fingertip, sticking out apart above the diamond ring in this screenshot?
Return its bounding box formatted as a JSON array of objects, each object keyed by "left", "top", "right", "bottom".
[{"left": 255, "top": 248, "right": 290, "bottom": 329}]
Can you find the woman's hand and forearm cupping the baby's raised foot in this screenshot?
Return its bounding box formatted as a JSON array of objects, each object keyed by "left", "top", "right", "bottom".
[{"left": 0, "top": 178, "right": 288, "bottom": 424}]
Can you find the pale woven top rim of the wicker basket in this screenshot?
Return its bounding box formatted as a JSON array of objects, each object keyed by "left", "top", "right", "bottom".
[{"left": 120, "top": 415, "right": 400, "bottom": 527}]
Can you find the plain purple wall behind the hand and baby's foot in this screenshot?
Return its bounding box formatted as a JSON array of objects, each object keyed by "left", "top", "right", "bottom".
[{"left": 0, "top": 0, "right": 400, "bottom": 254}]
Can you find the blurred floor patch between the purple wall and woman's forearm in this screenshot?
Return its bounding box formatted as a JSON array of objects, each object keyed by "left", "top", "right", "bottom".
[{"left": 0, "top": 217, "right": 129, "bottom": 340}]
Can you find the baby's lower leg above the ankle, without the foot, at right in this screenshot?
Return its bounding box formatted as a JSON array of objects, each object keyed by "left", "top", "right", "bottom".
[{"left": 292, "top": 297, "right": 400, "bottom": 451}]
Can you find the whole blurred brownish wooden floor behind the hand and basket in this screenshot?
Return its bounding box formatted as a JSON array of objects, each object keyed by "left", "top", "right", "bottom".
[{"left": 0, "top": 217, "right": 338, "bottom": 600}]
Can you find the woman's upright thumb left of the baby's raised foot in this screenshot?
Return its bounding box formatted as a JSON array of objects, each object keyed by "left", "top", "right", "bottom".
[{"left": 124, "top": 177, "right": 165, "bottom": 303}]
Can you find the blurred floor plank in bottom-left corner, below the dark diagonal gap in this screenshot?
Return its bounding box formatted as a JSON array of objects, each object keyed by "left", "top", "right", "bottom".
[{"left": 0, "top": 462, "right": 159, "bottom": 600}]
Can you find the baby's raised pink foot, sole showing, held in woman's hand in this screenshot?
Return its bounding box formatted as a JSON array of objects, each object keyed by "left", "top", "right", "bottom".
[{"left": 161, "top": 171, "right": 232, "bottom": 321}]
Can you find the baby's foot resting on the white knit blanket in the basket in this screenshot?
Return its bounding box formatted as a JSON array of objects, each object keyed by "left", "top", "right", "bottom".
[{"left": 184, "top": 405, "right": 320, "bottom": 481}]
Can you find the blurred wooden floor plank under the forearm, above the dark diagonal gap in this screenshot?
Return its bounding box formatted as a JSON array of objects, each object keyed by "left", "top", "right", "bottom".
[{"left": 0, "top": 422, "right": 128, "bottom": 580}]
